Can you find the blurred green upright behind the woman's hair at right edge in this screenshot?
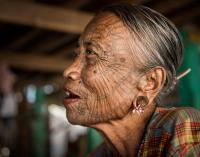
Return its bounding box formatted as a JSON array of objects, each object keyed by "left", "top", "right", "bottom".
[{"left": 179, "top": 30, "right": 200, "bottom": 109}]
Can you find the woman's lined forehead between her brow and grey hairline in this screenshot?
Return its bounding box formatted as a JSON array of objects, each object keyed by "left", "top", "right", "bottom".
[{"left": 80, "top": 13, "right": 130, "bottom": 49}]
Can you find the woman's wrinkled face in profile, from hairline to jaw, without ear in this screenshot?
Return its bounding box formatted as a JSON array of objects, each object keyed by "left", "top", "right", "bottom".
[{"left": 64, "top": 13, "right": 138, "bottom": 125}]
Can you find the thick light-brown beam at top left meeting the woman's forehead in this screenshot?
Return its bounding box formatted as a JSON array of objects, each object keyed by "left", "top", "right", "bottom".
[{"left": 0, "top": 0, "right": 93, "bottom": 33}]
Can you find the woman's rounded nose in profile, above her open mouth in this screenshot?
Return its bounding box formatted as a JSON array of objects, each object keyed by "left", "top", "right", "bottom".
[{"left": 63, "top": 59, "right": 81, "bottom": 81}]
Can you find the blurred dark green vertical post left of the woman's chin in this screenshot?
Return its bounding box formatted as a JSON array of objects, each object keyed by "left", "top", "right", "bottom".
[{"left": 31, "top": 87, "right": 48, "bottom": 157}]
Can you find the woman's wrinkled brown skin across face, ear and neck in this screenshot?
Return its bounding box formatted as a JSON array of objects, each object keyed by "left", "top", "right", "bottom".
[{"left": 64, "top": 12, "right": 162, "bottom": 157}]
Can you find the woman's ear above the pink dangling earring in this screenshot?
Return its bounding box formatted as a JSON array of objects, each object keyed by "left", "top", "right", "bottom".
[{"left": 138, "top": 66, "right": 166, "bottom": 99}]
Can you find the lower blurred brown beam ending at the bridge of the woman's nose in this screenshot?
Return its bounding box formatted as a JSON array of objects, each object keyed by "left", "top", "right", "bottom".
[{"left": 0, "top": 52, "right": 72, "bottom": 72}]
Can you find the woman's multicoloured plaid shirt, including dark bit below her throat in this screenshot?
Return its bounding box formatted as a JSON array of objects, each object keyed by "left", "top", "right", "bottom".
[{"left": 90, "top": 108, "right": 200, "bottom": 157}]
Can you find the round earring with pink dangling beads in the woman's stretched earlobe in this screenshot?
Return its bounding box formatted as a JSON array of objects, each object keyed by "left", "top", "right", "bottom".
[{"left": 132, "top": 96, "right": 149, "bottom": 114}]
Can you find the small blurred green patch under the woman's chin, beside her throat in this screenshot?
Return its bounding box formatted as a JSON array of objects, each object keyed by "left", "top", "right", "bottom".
[{"left": 88, "top": 128, "right": 102, "bottom": 153}]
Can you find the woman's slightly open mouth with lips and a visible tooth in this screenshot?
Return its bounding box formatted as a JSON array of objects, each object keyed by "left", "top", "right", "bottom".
[{"left": 63, "top": 89, "right": 80, "bottom": 106}]
